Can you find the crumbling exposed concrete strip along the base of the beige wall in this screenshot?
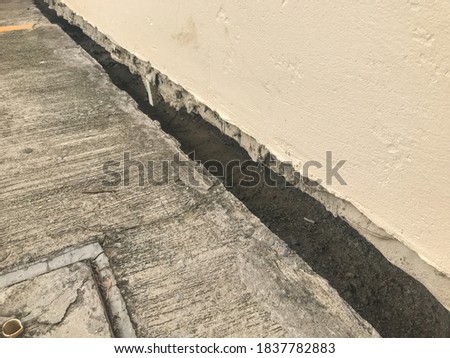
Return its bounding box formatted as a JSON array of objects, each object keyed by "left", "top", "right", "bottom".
[{"left": 43, "top": 0, "right": 450, "bottom": 310}]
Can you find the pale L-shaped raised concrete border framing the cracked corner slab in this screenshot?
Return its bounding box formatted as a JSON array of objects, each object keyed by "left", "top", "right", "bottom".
[{"left": 0, "top": 242, "right": 136, "bottom": 338}]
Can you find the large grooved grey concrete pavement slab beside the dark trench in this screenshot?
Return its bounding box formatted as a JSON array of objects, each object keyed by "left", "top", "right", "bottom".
[{"left": 0, "top": 0, "right": 377, "bottom": 337}]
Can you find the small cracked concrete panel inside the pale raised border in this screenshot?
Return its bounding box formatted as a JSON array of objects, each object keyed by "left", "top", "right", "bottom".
[{"left": 0, "top": 263, "right": 112, "bottom": 338}]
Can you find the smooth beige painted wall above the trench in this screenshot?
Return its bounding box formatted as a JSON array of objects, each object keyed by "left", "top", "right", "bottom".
[{"left": 60, "top": 0, "right": 450, "bottom": 274}]
